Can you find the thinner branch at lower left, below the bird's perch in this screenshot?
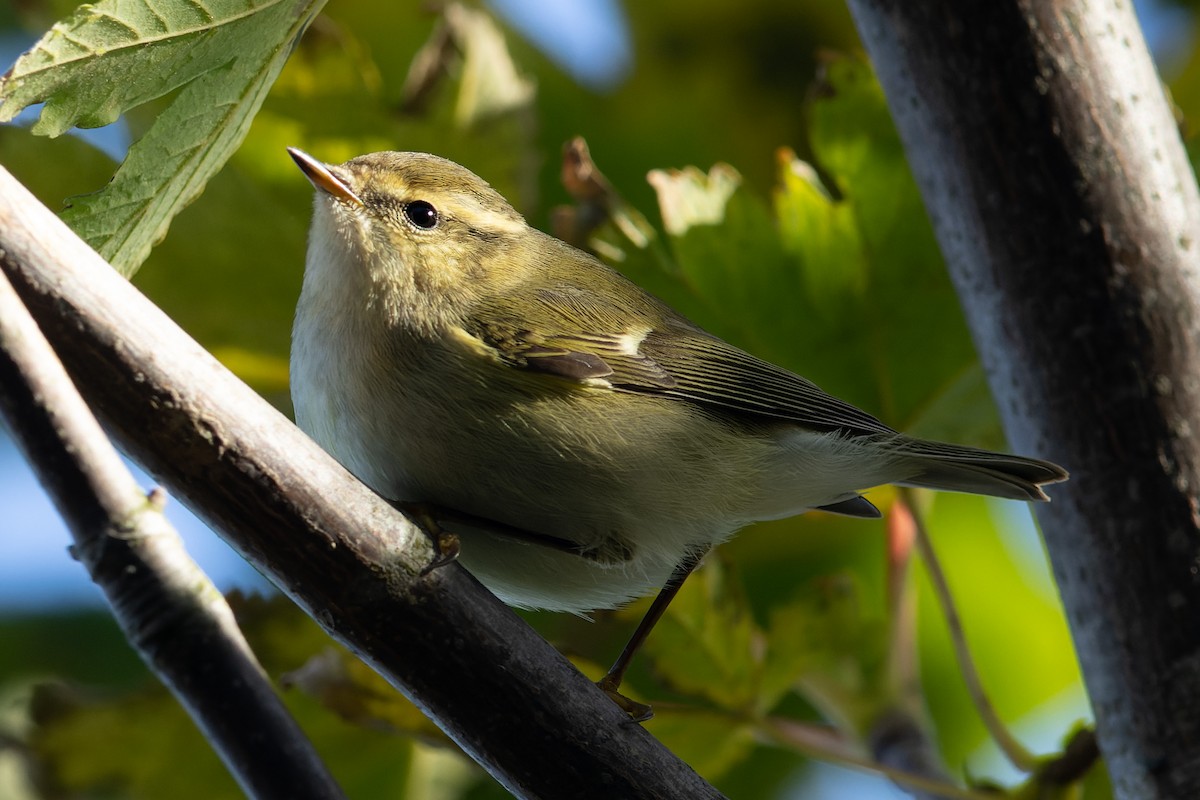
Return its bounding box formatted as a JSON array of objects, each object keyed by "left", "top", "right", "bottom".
[{"left": 0, "top": 275, "right": 344, "bottom": 800}]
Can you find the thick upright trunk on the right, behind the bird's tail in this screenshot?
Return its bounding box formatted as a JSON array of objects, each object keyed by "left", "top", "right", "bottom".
[{"left": 850, "top": 0, "right": 1200, "bottom": 800}]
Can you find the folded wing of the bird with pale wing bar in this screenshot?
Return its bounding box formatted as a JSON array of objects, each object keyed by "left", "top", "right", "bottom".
[{"left": 470, "top": 290, "right": 895, "bottom": 435}]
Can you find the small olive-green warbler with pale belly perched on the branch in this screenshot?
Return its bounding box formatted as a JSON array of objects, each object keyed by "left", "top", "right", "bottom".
[{"left": 289, "top": 149, "right": 1067, "bottom": 714}]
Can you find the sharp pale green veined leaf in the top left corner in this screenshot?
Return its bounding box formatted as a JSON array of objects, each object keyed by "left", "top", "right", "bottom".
[{"left": 0, "top": 0, "right": 324, "bottom": 275}]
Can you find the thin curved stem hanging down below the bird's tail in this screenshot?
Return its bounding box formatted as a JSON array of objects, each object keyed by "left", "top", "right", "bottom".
[{"left": 899, "top": 487, "right": 1038, "bottom": 772}]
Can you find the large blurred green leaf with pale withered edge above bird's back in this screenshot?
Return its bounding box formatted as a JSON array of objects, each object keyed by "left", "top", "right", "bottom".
[{"left": 626, "top": 58, "right": 998, "bottom": 444}]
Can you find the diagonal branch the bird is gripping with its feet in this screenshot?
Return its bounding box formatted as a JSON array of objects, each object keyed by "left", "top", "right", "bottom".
[{"left": 0, "top": 165, "right": 721, "bottom": 799}]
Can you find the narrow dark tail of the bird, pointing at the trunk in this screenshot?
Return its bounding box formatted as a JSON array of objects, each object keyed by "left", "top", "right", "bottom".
[{"left": 888, "top": 437, "right": 1067, "bottom": 500}]
